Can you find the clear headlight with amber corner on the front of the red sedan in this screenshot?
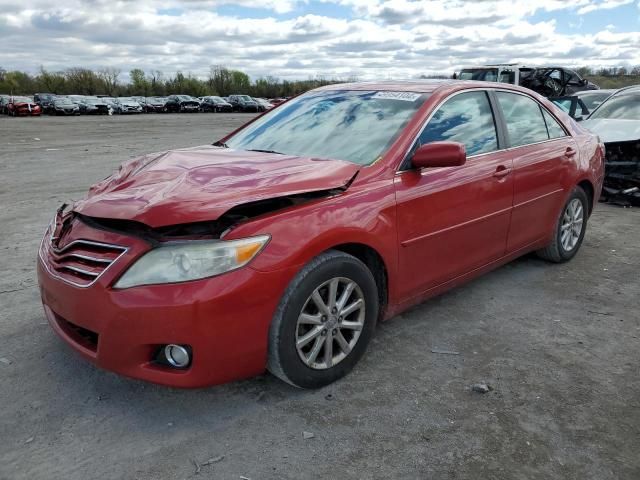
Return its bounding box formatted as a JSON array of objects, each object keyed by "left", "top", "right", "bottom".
[{"left": 114, "top": 235, "right": 270, "bottom": 288}]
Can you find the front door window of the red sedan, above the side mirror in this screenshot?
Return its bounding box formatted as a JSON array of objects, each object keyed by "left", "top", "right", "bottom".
[{"left": 416, "top": 92, "right": 498, "bottom": 155}]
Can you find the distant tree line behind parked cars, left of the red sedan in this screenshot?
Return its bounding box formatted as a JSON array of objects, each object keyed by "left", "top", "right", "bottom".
[{"left": 0, "top": 65, "right": 357, "bottom": 98}]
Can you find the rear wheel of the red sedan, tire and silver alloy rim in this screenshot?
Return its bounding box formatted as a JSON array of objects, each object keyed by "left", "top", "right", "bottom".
[{"left": 536, "top": 187, "right": 589, "bottom": 263}]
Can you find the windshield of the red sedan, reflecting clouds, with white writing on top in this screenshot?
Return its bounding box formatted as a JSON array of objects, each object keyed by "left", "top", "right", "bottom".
[{"left": 227, "top": 90, "right": 428, "bottom": 165}]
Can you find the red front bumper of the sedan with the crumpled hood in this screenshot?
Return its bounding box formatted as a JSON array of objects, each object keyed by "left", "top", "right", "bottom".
[{"left": 38, "top": 214, "right": 295, "bottom": 388}]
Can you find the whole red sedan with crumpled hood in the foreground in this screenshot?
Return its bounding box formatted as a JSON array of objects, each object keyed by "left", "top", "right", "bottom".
[{"left": 38, "top": 81, "right": 604, "bottom": 388}]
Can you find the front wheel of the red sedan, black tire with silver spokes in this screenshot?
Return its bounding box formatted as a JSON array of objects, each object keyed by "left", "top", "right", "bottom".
[{"left": 267, "top": 250, "right": 379, "bottom": 388}]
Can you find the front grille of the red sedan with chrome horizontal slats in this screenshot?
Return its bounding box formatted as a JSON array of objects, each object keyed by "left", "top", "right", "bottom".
[{"left": 48, "top": 240, "right": 127, "bottom": 287}]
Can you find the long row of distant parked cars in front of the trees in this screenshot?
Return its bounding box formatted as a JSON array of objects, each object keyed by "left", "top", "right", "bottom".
[{"left": 0, "top": 93, "right": 286, "bottom": 116}]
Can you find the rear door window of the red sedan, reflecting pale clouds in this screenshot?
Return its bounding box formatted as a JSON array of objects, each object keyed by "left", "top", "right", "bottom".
[{"left": 496, "top": 92, "right": 549, "bottom": 147}]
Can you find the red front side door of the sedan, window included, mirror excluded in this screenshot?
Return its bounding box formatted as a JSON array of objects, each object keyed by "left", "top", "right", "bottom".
[{"left": 395, "top": 90, "right": 513, "bottom": 298}]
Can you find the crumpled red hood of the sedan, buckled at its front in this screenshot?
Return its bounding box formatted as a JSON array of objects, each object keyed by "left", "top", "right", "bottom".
[{"left": 73, "top": 146, "right": 360, "bottom": 228}]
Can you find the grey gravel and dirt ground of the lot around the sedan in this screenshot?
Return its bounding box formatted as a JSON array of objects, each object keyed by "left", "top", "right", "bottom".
[{"left": 0, "top": 114, "right": 640, "bottom": 480}]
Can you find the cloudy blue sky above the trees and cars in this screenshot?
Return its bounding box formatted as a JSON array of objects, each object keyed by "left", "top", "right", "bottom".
[{"left": 0, "top": 0, "right": 640, "bottom": 79}]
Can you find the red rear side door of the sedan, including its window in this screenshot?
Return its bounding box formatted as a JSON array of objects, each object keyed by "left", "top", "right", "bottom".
[{"left": 496, "top": 91, "right": 577, "bottom": 252}]
